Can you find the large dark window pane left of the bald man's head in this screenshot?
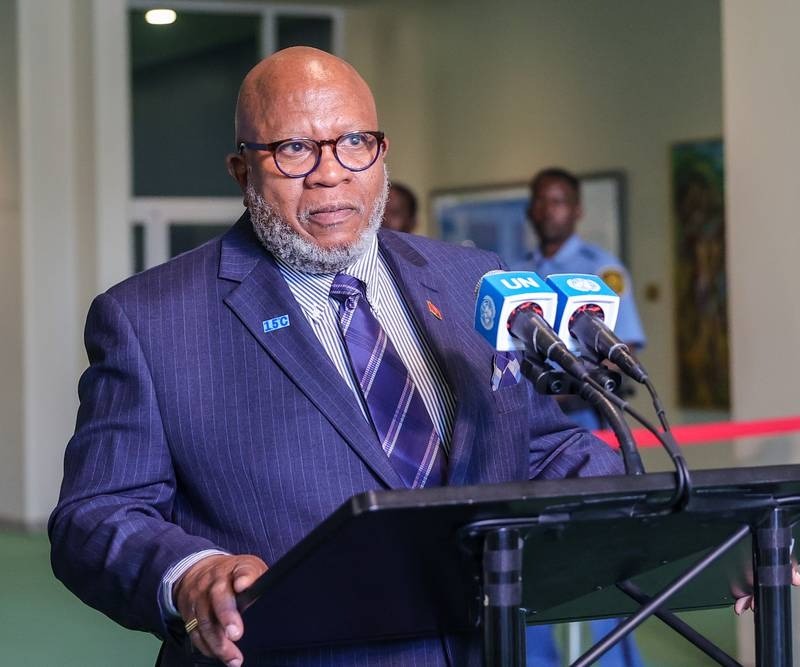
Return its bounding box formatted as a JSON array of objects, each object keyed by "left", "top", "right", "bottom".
[{"left": 129, "top": 11, "right": 261, "bottom": 197}]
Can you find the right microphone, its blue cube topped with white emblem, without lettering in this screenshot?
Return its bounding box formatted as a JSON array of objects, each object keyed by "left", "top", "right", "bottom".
[{"left": 547, "top": 274, "right": 648, "bottom": 384}]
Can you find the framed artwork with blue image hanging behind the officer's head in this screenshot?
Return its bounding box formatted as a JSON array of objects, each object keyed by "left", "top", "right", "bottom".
[{"left": 431, "top": 171, "right": 627, "bottom": 266}]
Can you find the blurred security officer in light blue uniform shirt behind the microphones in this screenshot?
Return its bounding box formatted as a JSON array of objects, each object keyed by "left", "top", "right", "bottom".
[{"left": 514, "top": 168, "right": 645, "bottom": 667}]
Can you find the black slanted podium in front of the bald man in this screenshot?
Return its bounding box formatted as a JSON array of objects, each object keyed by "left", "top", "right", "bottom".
[{"left": 238, "top": 465, "right": 800, "bottom": 667}]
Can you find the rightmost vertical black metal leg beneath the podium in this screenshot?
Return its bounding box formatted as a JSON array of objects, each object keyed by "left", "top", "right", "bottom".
[{"left": 753, "top": 507, "right": 792, "bottom": 667}]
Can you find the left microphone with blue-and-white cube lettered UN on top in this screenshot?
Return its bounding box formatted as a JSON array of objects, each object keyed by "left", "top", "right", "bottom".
[{"left": 475, "top": 271, "right": 589, "bottom": 381}]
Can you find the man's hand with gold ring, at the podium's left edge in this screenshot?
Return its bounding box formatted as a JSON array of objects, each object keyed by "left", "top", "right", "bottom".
[{"left": 173, "top": 555, "right": 267, "bottom": 667}]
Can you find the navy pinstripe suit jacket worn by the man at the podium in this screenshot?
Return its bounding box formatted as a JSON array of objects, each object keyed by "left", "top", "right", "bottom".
[{"left": 49, "top": 215, "right": 621, "bottom": 667}]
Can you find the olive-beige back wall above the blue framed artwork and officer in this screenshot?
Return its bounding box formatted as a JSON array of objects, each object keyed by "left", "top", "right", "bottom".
[{"left": 346, "top": 0, "right": 722, "bottom": 466}]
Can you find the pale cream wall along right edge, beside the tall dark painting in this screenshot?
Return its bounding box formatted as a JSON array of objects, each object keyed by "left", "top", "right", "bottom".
[{"left": 722, "top": 0, "right": 800, "bottom": 664}]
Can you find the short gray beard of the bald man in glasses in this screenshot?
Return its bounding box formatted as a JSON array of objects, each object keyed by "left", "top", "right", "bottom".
[{"left": 246, "top": 164, "right": 389, "bottom": 273}]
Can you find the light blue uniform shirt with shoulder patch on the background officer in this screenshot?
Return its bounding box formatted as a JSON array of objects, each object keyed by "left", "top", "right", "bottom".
[{"left": 513, "top": 234, "right": 647, "bottom": 348}]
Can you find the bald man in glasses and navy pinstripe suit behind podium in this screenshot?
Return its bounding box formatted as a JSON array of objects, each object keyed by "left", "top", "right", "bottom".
[{"left": 49, "top": 47, "right": 621, "bottom": 667}]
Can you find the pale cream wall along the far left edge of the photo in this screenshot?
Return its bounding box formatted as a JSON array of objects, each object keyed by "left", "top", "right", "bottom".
[{"left": 0, "top": 0, "right": 95, "bottom": 525}]
